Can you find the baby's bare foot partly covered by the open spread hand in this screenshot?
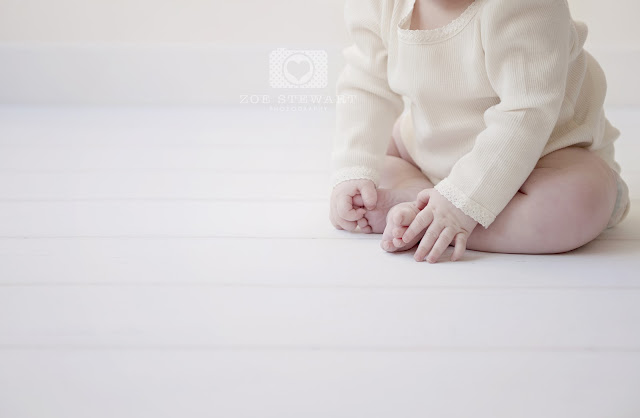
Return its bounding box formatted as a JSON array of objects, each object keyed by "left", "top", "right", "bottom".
[{"left": 380, "top": 201, "right": 426, "bottom": 253}]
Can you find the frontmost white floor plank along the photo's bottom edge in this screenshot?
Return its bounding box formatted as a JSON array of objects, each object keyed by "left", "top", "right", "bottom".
[{"left": 0, "top": 350, "right": 640, "bottom": 418}]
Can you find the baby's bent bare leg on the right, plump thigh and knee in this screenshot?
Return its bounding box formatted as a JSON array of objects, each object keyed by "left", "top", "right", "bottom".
[{"left": 467, "top": 147, "right": 617, "bottom": 254}]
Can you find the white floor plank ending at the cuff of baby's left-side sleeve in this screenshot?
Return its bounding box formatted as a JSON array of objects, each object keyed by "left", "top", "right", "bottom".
[{"left": 0, "top": 170, "right": 329, "bottom": 201}]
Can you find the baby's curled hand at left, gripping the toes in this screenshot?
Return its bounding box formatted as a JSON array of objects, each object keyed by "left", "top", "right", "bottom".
[{"left": 329, "top": 179, "right": 378, "bottom": 232}]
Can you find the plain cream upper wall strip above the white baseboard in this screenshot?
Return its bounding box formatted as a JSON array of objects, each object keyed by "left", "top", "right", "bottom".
[{"left": 0, "top": 0, "right": 640, "bottom": 46}]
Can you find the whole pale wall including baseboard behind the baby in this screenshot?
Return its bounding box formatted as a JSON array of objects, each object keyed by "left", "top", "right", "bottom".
[{"left": 0, "top": 0, "right": 640, "bottom": 105}]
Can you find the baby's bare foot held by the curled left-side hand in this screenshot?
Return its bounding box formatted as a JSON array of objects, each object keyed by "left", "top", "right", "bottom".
[{"left": 353, "top": 189, "right": 421, "bottom": 234}]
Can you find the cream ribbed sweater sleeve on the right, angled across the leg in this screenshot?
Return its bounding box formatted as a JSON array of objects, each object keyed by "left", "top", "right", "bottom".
[{"left": 435, "top": 0, "right": 573, "bottom": 229}]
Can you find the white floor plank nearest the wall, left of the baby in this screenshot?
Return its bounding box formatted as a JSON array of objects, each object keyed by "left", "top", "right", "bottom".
[{"left": 0, "top": 105, "right": 335, "bottom": 147}]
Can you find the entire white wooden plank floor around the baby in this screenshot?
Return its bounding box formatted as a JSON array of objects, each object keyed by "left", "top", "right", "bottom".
[{"left": 0, "top": 107, "right": 640, "bottom": 418}]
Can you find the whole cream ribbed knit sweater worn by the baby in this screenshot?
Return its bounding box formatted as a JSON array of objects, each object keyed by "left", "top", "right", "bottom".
[{"left": 331, "top": 0, "right": 620, "bottom": 228}]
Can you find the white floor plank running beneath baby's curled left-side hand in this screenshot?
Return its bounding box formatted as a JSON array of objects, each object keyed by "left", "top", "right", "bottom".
[{"left": 0, "top": 200, "right": 640, "bottom": 240}]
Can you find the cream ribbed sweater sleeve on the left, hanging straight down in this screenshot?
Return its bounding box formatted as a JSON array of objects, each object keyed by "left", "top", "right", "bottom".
[{"left": 331, "top": 0, "right": 404, "bottom": 187}]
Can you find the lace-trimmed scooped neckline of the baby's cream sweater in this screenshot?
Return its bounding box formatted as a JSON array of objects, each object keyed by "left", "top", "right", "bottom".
[{"left": 397, "top": 0, "right": 484, "bottom": 44}]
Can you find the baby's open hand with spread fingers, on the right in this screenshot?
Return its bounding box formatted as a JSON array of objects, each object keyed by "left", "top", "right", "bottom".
[{"left": 402, "top": 188, "right": 478, "bottom": 263}]
